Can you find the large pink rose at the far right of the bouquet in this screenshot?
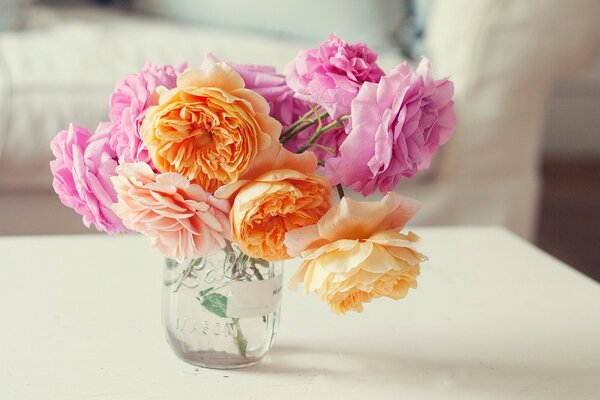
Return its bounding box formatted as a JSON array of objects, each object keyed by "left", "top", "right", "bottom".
[{"left": 326, "top": 59, "right": 456, "bottom": 196}]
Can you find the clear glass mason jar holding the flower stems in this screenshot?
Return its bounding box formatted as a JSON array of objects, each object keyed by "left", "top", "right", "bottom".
[{"left": 162, "top": 244, "right": 283, "bottom": 368}]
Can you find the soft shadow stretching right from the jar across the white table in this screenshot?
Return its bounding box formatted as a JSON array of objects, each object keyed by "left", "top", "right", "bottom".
[{"left": 248, "top": 345, "right": 600, "bottom": 399}]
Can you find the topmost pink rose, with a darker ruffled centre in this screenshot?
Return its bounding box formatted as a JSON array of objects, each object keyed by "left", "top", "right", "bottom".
[{"left": 285, "top": 34, "right": 384, "bottom": 119}]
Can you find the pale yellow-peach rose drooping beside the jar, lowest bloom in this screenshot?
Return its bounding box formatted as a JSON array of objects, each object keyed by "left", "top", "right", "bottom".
[{"left": 285, "top": 193, "right": 427, "bottom": 314}]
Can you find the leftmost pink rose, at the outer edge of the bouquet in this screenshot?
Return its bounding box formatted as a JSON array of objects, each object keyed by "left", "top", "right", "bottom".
[{"left": 50, "top": 123, "right": 127, "bottom": 234}]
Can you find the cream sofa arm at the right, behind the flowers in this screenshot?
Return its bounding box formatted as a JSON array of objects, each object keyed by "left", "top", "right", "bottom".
[{"left": 409, "top": 0, "right": 600, "bottom": 238}]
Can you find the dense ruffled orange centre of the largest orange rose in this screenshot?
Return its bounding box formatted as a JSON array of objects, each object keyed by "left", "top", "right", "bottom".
[{"left": 149, "top": 94, "right": 260, "bottom": 192}]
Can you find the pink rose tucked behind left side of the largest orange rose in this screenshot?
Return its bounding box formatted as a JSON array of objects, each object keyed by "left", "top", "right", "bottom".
[{"left": 109, "top": 63, "right": 187, "bottom": 165}]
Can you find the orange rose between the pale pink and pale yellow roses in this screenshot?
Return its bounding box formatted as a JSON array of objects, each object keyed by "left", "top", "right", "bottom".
[{"left": 215, "top": 143, "right": 332, "bottom": 261}]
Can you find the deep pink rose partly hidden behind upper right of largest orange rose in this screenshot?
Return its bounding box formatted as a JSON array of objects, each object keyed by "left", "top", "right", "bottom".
[{"left": 204, "top": 54, "right": 310, "bottom": 131}]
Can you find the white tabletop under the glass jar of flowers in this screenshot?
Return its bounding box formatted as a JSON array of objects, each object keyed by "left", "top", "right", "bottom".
[{"left": 0, "top": 228, "right": 600, "bottom": 400}]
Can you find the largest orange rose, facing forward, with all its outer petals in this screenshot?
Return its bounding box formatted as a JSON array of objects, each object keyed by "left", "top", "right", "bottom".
[{"left": 141, "top": 63, "right": 281, "bottom": 192}]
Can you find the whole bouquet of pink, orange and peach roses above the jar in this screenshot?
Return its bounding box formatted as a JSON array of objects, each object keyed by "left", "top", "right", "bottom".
[{"left": 50, "top": 35, "right": 455, "bottom": 313}]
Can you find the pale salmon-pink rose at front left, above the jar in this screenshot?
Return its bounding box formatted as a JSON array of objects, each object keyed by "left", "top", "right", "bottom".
[{"left": 112, "top": 163, "right": 230, "bottom": 262}]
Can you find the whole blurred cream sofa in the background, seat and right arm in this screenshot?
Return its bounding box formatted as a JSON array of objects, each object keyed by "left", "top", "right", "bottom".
[{"left": 0, "top": 0, "right": 600, "bottom": 238}]
